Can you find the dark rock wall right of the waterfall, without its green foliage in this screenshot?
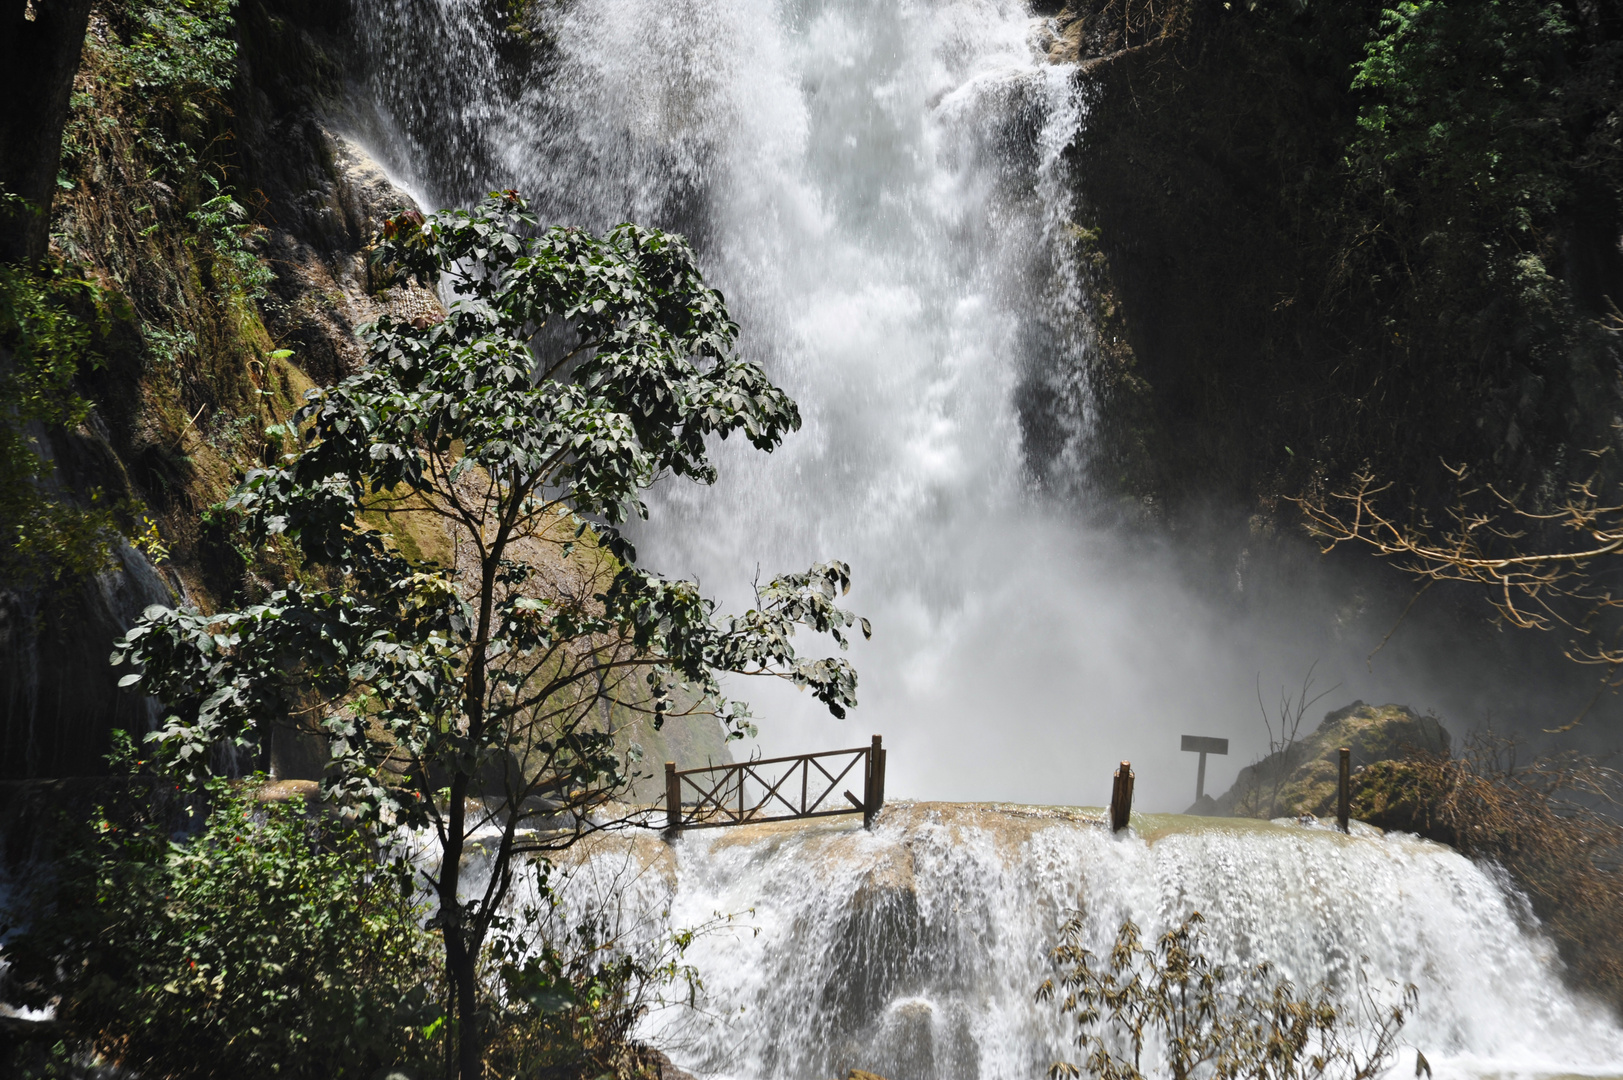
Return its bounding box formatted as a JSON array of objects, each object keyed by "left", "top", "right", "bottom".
[{"left": 1053, "top": 0, "right": 1623, "bottom": 521}]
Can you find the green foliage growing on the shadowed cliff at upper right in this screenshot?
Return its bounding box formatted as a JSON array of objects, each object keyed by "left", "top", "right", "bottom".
[{"left": 1330, "top": 0, "right": 1597, "bottom": 399}]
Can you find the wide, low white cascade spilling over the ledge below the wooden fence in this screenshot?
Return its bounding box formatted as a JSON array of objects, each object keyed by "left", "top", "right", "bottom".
[{"left": 548, "top": 802, "right": 1623, "bottom": 1080}]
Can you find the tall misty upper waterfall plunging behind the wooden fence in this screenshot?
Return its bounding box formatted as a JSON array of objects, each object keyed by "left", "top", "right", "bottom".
[{"left": 342, "top": 0, "right": 1343, "bottom": 809}]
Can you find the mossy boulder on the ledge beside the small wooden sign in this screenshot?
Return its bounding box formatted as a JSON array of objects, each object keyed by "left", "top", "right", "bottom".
[{"left": 1216, "top": 702, "right": 1449, "bottom": 820}]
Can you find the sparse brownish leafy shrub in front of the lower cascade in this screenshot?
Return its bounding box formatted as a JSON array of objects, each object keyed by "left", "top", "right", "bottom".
[{"left": 1037, "top": 911, "right": 1415, "bottom": 1080}]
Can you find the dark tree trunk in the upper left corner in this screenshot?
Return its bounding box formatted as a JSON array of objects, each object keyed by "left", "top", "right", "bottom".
[{"left": 0, "top": 0, "right": 91, "bottom": 263}]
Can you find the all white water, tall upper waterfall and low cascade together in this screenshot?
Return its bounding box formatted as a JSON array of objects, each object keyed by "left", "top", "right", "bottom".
[{"left": 355, "top": 0, "right": 1623, "bottom": 1080}]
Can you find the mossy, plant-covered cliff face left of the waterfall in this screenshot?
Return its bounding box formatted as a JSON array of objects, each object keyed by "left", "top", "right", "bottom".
[{"left": 0, "top": 0, "right": 440, "bottom": 780}]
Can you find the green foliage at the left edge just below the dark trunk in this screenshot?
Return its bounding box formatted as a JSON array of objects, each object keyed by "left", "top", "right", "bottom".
[{"left": 0, "top": 265, "right": 115, "bottom": 586}]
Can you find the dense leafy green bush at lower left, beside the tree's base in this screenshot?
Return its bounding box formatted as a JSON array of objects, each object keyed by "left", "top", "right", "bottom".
[{"left": 5, "top": 734, "right": 441, "bottom": 1078}]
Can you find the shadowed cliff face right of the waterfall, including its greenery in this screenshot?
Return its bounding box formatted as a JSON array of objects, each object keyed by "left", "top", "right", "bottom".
[{"left": 1050, "top": 0, "right": 1623, "bottom": 520}]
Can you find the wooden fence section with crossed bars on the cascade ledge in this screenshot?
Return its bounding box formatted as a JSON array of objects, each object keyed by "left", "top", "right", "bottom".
[{"left": 665, "top": 736, "right": 885, "bottom": 835}]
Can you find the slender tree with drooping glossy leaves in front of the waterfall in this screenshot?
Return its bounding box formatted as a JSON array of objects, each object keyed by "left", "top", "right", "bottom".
[{"left": 114, "top": 192, "right": 868, "bottom": 1080}]
